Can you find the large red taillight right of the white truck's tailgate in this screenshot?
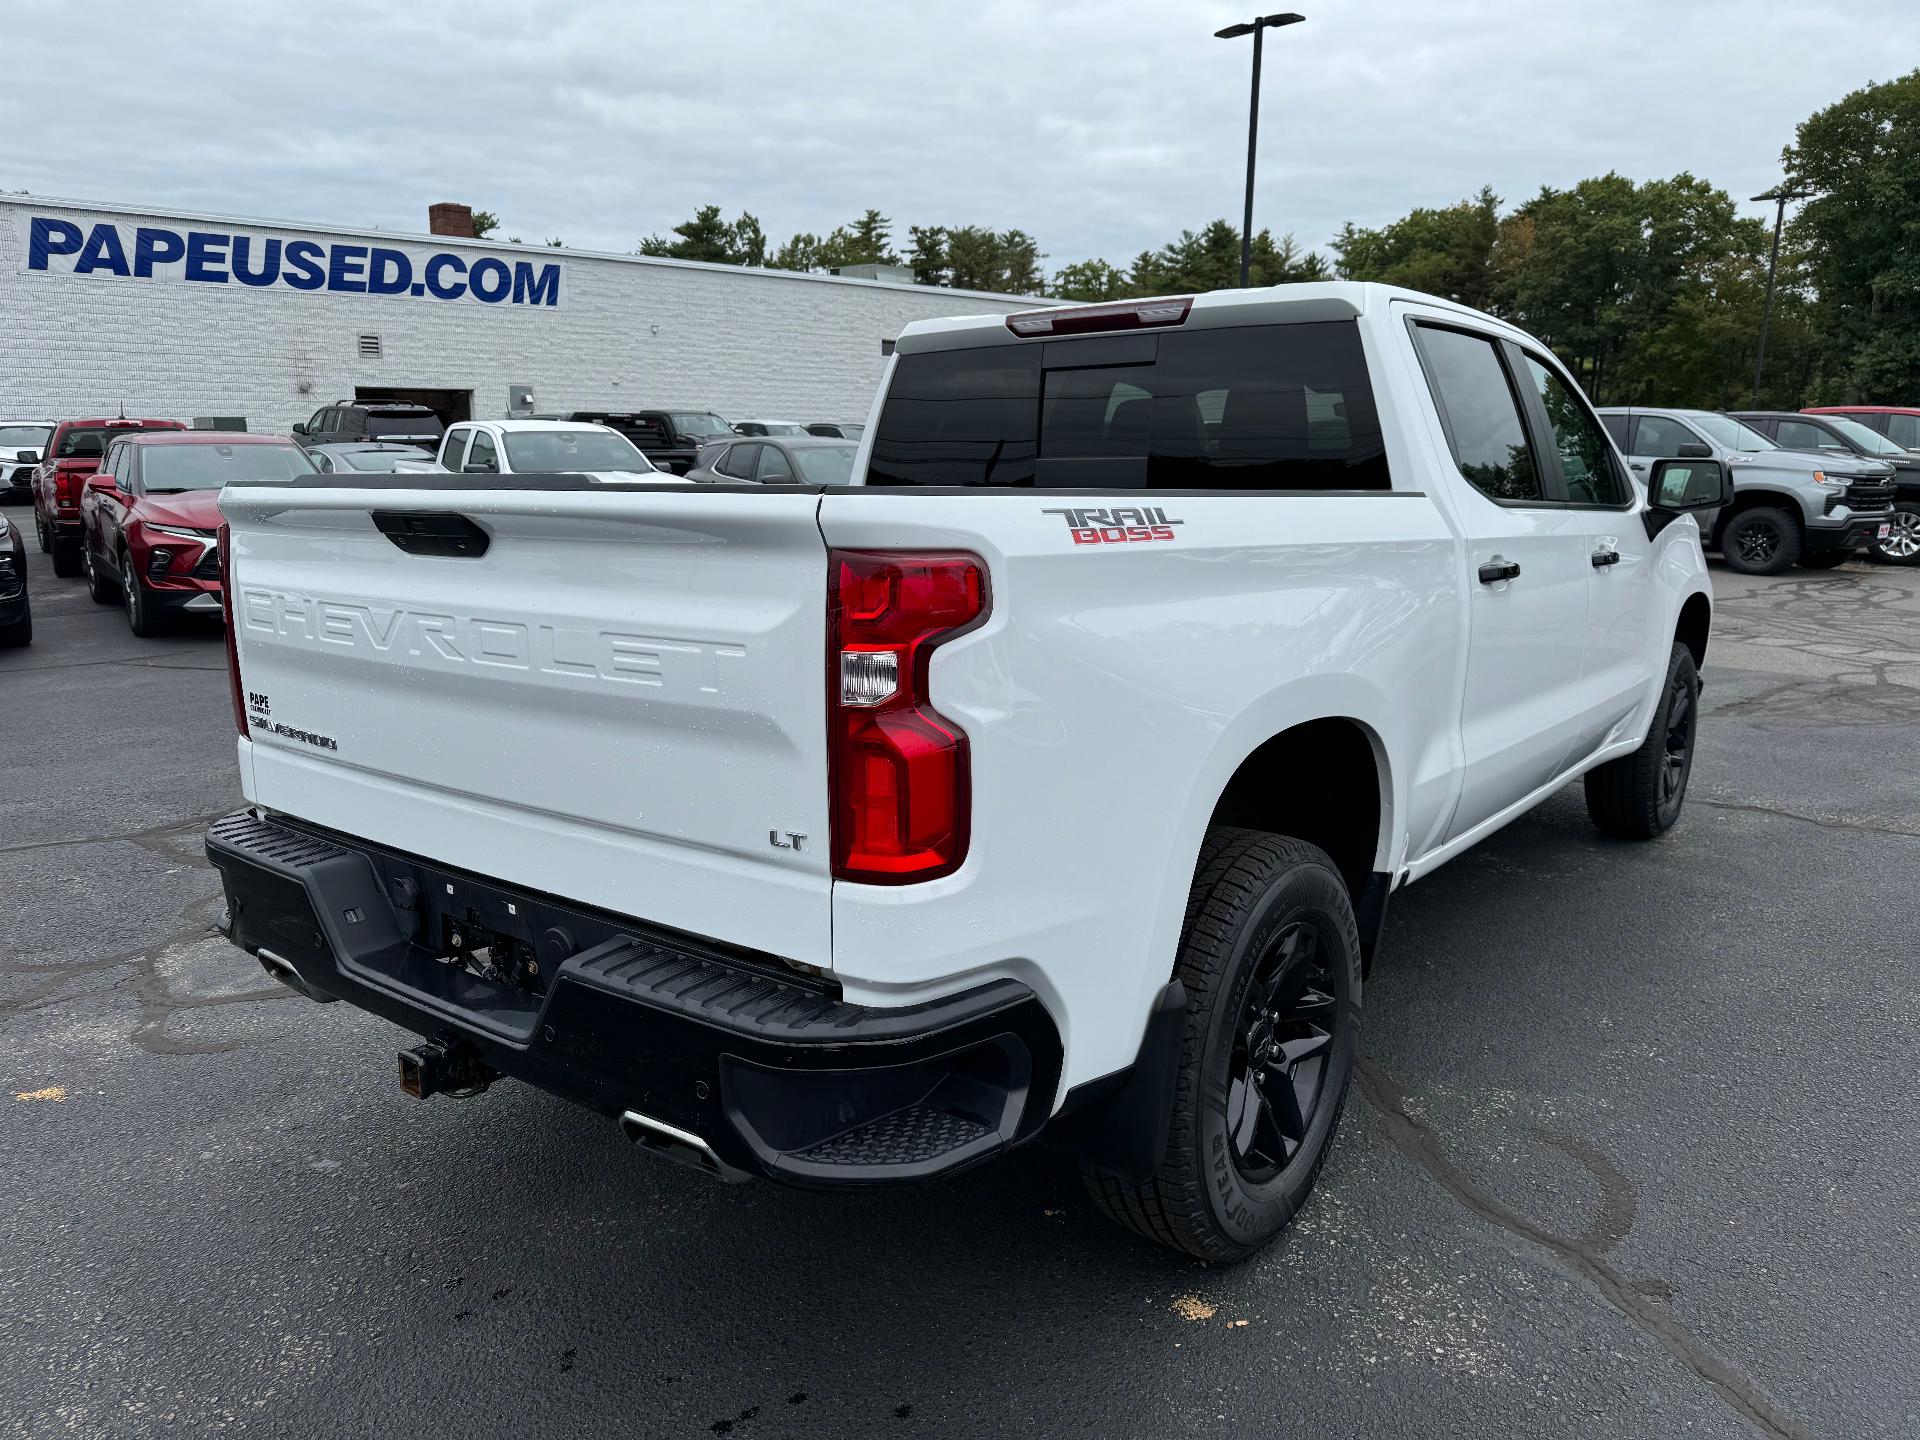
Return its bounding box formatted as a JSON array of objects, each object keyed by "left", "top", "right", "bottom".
[{"left": 828, "top": 549, "right": 987, "bottom": 885}]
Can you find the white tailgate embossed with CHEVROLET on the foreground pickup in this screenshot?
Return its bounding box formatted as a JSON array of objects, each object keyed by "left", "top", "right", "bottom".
[{"left": 221, "top": 482, "right": 831, "bottom": 966}]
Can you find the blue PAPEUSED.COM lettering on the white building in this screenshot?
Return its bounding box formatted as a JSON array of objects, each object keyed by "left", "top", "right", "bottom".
[{"left": 25, "top": 215, "right": 563, "bottom": 309}]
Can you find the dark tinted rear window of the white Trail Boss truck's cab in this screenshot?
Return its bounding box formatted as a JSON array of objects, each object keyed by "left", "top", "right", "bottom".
[{"left": 866, "top": 321, "right": 1390, "bottom": 490}]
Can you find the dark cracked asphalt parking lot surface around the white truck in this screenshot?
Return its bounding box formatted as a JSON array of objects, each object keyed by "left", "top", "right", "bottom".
[{"left": 0, "top": 533, "right": 1920, "bottom": 1438}]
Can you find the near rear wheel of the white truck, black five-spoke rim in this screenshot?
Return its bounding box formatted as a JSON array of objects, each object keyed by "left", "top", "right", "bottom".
[{"left": 1085, "top": 828, "right": 1359, "bottom": 1260}]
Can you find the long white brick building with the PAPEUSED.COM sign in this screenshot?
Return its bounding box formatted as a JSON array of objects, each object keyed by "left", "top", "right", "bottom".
[{"left": 0, "top": 196, "right": 1037, "bottom": 434}]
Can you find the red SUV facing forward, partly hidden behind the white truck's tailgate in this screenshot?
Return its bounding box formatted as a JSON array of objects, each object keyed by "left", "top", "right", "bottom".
[{"left": 81, "top": 430, "right": 319, "bottom": 636}]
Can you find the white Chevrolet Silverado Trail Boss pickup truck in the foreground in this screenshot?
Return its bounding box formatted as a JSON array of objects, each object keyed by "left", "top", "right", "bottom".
[{"left": 207, "top": 284, "right": 1728, "bottom": 1260}]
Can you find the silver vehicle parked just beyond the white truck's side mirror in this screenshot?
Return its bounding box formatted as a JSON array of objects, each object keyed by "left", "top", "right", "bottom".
[{"left": 1599, "top": 405, "right": 1893, "bottom": 574}]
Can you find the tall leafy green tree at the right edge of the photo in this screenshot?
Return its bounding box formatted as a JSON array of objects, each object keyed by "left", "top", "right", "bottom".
[{"left": 1766, "top": 71, "right": 1920, "bottom": 403}]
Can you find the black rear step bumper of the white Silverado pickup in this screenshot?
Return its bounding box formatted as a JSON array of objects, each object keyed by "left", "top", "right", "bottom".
[{"left": 207, "top": 810, "right": 1060, "bottom": 1187}]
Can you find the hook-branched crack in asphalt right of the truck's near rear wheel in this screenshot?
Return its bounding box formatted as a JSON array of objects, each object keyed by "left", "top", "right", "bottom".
[{"left": 1354, "top": 1058, "right": 1814, "bottom": 1440}]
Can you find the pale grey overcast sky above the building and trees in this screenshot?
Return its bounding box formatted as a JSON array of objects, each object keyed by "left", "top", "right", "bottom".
[{"left": 0, "top": 0, "right": 1889, "bottom": 271}]
